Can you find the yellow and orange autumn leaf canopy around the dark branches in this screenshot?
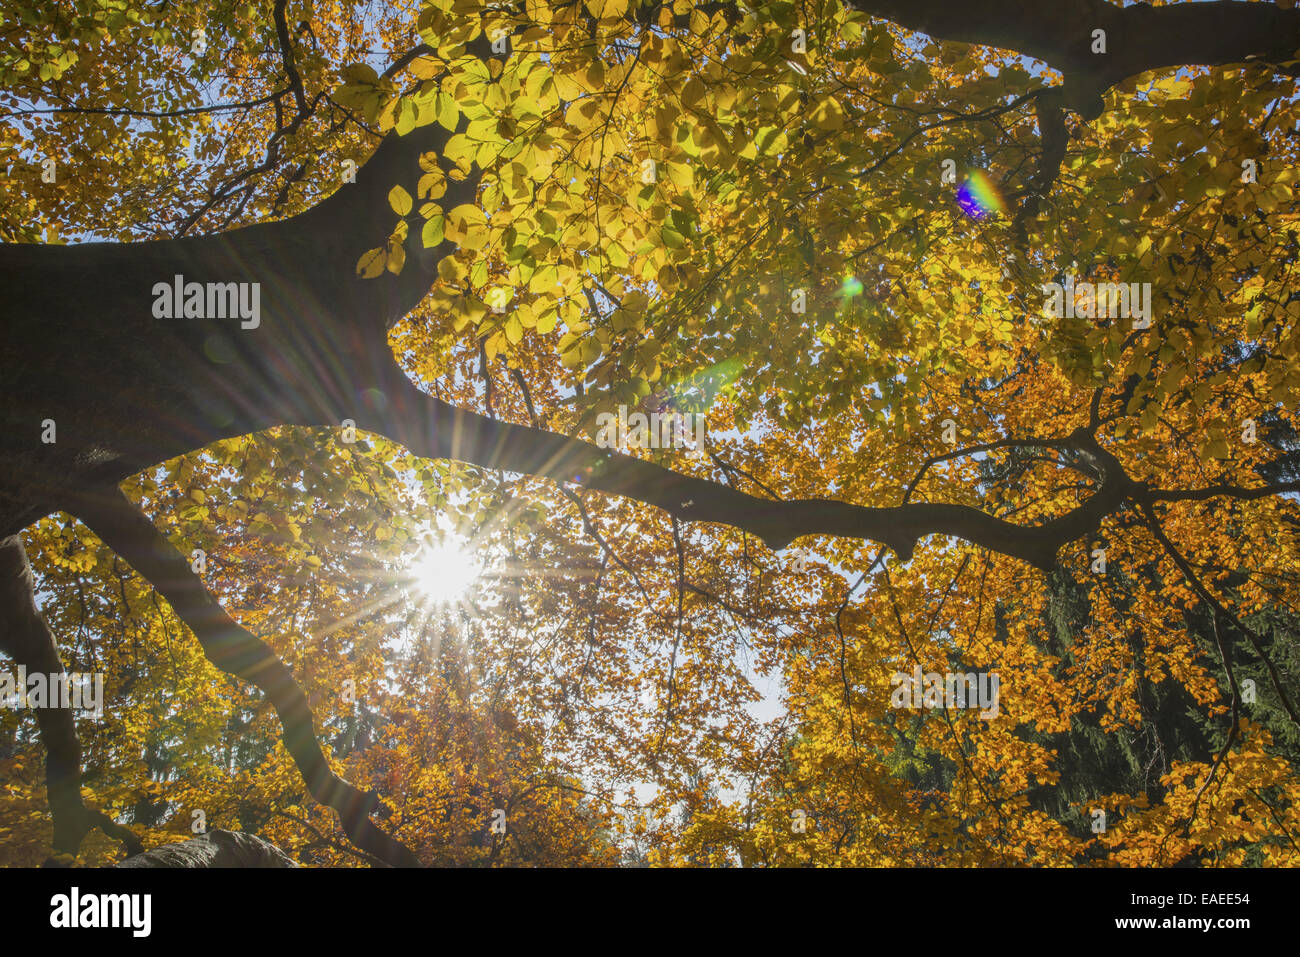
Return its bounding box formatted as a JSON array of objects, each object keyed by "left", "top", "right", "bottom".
[{"left": 0, "top": 0, "right": 1300, "bottom": 867}]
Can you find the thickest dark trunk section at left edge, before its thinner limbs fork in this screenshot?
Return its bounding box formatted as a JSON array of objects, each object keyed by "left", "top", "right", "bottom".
[{"left": 0, "top": 65, "right": 477, "bottom": 536}]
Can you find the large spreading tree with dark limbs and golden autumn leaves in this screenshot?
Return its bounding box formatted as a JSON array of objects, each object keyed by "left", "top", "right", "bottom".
[{"left": 0, "top": 0, "right": 1300, "bottom": 865}]
